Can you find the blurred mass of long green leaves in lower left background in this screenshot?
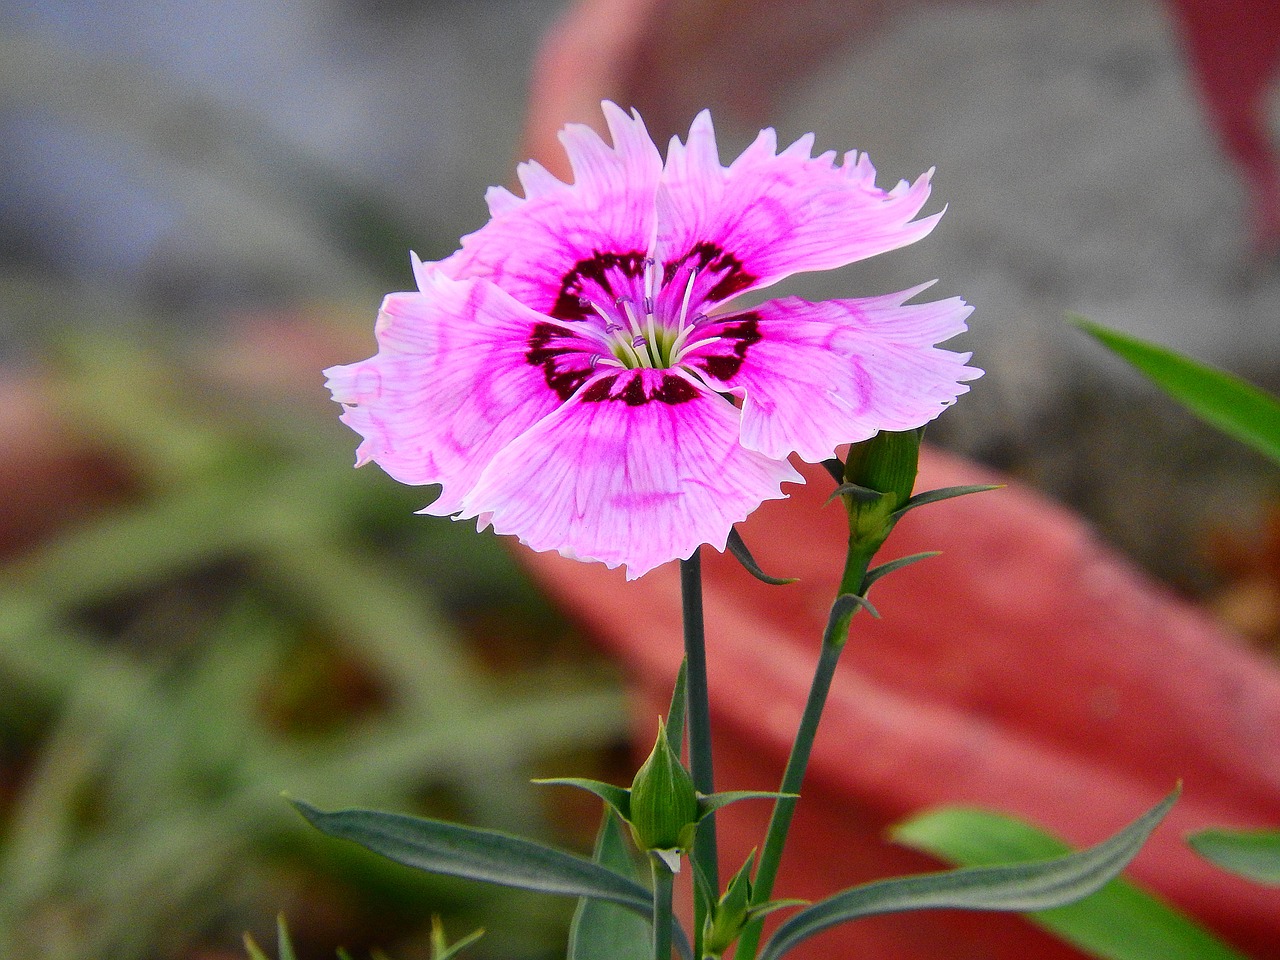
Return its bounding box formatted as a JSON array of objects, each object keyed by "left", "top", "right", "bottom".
[{"left": 0, "top": 335, "right": 625, "bottom": 960}]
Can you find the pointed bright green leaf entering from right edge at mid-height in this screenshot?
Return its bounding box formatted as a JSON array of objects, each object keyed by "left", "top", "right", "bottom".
[{"left": 1068, "top": 315, "right": 1280, "bottom": 463}]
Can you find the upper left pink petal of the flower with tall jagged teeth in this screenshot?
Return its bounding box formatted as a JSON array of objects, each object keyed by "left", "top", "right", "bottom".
[{"left": 434, "top": 102, "right": 662, "bottom": 316}]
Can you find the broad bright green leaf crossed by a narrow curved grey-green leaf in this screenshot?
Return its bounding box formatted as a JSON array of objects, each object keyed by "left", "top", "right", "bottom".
[{"left": 893, "top": 808, "right": 1244, "bottom": 960}]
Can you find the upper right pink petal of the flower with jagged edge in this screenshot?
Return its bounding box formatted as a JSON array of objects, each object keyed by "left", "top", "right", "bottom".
[{"left": 658, "top": 110, "right": 941, "bottom": 303}]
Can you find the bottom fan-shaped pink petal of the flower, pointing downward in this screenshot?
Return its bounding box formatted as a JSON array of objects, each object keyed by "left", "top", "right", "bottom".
[{"left": 463, "top": 370, "right": 800, "bottom": 580}]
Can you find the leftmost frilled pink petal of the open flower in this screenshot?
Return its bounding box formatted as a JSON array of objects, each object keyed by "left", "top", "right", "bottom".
[{"left": 325, "top": 271, "right": 590, "bottom": 516}]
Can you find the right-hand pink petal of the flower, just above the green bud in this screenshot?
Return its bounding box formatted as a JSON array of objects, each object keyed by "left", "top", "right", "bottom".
[{"left": 684, "top": 284, "right": 982, "bottom": 463}]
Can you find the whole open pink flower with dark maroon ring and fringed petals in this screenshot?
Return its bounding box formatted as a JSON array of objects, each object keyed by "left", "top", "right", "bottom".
[{"left": 325, "top": 102, "right": 980, "bottom": 579}]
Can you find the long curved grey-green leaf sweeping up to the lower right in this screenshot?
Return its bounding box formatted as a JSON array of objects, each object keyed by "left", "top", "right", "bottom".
[{"left": 760, "top": 791, "right": 1179, "bottom": 960}]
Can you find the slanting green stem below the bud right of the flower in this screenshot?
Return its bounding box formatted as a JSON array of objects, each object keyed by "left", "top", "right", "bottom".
[{"left": 733, "top": 536, "right": 881, "bottom": 960}]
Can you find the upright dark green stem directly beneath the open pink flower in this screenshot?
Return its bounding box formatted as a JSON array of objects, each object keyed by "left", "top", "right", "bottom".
[{"left": 680, "top": 548, "right": 719, "bottom": 891}]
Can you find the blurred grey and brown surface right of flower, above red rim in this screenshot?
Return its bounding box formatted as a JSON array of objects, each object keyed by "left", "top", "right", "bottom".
[{"left": 778, "top": 0, "right": 1280, "bottom": 585}]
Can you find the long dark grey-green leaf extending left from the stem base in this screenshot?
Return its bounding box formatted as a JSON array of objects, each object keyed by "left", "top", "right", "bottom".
[{"left": 292, "top": 800, "right": 653, "bottom": 916}]
